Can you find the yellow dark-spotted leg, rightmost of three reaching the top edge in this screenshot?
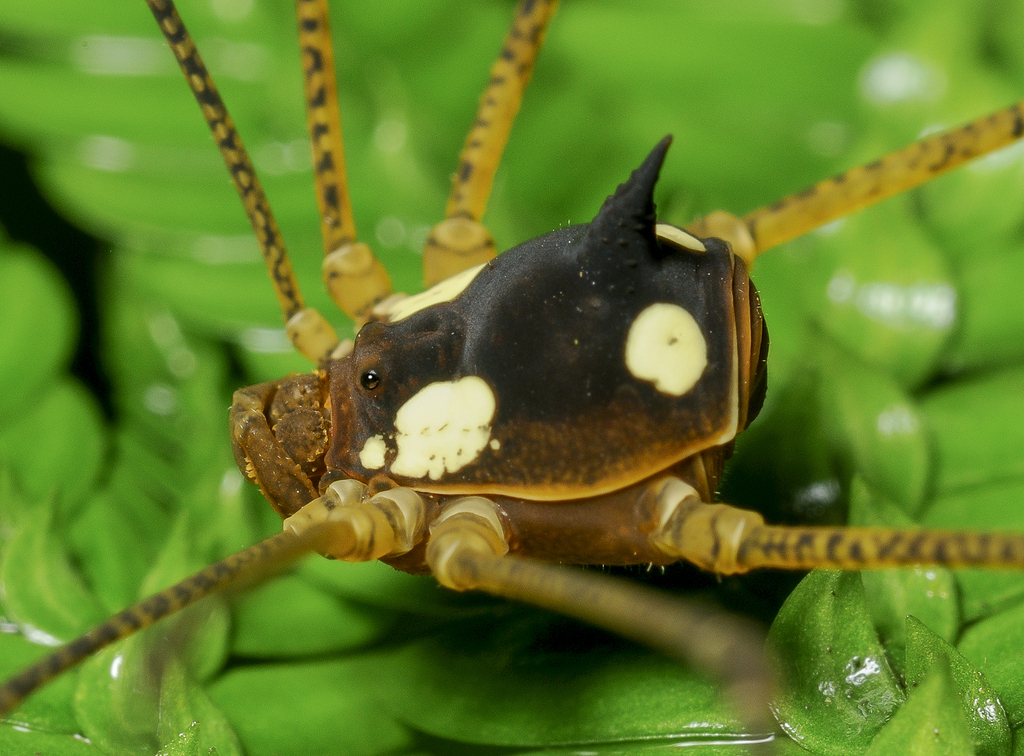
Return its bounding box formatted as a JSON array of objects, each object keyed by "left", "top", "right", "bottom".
[{"left": 423, "top": 0, "right": 558, "bottom": 287}]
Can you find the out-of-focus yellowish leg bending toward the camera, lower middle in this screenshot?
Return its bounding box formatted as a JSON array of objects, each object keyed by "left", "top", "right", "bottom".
[{"left": 427, "top": 497, "right": 774, "bottom": 732}]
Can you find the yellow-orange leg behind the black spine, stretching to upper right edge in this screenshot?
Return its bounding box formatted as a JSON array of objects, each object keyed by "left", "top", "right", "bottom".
[{"left": 686, "top": 102, "right": 1024, "bottom": 266}]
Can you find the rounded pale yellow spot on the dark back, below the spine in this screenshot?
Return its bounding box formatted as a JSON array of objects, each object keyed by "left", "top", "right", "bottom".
[{"left": 626, "top": 302, "right": 708, "bottom": 396}]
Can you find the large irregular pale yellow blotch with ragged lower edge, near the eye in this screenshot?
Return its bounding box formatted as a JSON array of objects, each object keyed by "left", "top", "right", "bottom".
[{"left": 391, "top": 376, "right": 496, "bottom": 480}]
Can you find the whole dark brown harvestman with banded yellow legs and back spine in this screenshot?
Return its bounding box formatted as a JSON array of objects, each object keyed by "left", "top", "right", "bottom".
[{"left": 0, "top": 0, "right": 1024, "bottom": 727}]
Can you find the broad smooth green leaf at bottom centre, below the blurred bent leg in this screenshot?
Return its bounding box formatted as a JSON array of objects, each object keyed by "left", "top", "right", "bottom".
[{"left": 366, "top": 614, "right": 742, "bottom": 747}]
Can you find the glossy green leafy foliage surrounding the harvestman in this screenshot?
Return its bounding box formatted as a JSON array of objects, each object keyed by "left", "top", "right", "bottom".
[{"left": 0, "top": 0, "right": 1024, "bottom": 754}]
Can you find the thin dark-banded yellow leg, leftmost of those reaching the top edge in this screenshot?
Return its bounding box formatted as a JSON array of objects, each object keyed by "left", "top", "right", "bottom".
[{"left": 146, "top": 0, "right": 338, "bottom": 364}]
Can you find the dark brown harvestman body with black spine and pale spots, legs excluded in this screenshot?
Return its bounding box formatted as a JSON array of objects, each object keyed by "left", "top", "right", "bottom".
[{"left": 231, "top": 139, "right": 768, "bottom": 572}]
